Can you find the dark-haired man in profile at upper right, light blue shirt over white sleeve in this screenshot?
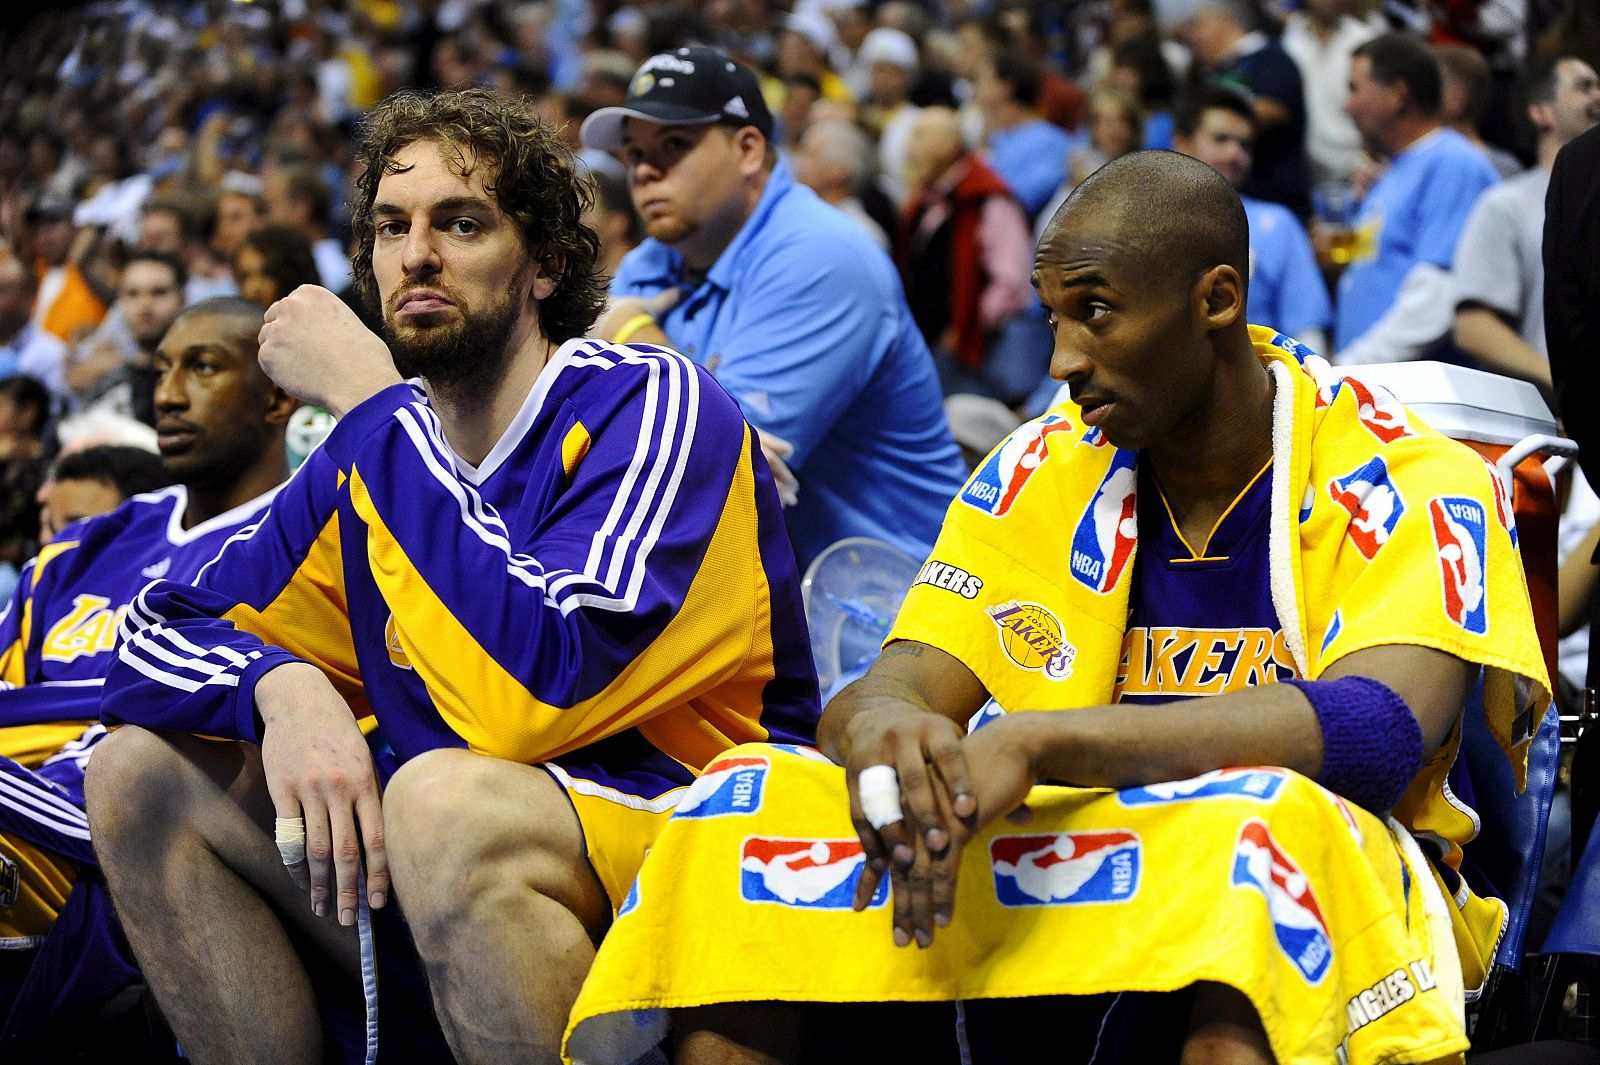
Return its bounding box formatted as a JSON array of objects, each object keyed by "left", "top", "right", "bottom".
[{"left": 1333, "top": 34, "right": 1499, "bottom": 365}]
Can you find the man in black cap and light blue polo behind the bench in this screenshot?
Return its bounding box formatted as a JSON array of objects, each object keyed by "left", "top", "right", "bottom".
[{"left": 582, "top": 48, "right": 963, "bottom": 566}]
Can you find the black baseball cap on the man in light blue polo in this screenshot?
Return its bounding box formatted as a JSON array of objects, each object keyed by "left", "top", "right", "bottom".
[{"left": 579, "top": 48, "right": 773, "bottom": 152}]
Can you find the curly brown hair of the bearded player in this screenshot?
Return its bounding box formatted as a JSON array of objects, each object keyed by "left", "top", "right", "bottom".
[{"left": 350, "top": 90, "right": 606, "bottom": 344}]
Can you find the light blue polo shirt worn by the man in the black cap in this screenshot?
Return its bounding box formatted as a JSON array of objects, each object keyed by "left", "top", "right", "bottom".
[{"left": 611, "top": 162, "right": 965, "bottom": 566}]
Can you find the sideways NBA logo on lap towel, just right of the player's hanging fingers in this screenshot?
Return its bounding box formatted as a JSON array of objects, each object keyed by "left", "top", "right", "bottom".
[{"left": 989, "top": 830, "right": 1142, "bottom": 907}]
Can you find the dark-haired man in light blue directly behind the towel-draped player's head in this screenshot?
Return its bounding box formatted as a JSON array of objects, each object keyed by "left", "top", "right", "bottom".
[{"left": 1173, "top": 85, "right": 1333, "bottom": 352}]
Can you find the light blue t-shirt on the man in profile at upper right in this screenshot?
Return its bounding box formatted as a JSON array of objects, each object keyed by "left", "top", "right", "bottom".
[{"left": 1333, "top": 130, "right": 1499, "bottom": 352}]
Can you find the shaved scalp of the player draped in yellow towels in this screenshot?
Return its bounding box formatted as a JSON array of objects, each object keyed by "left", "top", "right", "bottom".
[{"left": 1040, "top": 152, "right": 1250, "bottom": 299}]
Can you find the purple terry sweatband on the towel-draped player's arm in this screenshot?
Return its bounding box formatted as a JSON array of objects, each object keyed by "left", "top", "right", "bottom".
[{"left": 1283, "top": 676, "right": 1422, "bottom": 814}]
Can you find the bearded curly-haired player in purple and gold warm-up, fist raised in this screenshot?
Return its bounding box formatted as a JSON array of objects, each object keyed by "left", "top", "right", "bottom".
[{"left": 88, "top": 91, "right": 818, "bottom": 1062}]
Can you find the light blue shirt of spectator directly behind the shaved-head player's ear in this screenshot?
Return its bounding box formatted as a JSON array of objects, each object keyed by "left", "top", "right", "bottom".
[{"left": 1240, "top": 197, "right": 1333, "bottom": 336}]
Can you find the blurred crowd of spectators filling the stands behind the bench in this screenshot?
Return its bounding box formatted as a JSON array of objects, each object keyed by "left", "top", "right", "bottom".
[{"left": 0, "top": 0, "right": 1600, "bottom": 671}]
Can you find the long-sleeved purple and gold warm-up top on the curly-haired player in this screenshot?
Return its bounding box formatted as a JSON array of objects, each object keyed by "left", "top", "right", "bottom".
[{"left": 104, "top": 339, "right": 819, "bottom": 800}]
